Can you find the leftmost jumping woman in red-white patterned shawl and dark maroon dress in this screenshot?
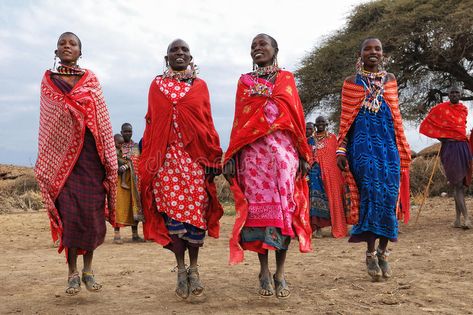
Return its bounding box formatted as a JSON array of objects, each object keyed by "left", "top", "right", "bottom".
[{"left": 35, "top": 32, "right": 117, "bottom": 295}]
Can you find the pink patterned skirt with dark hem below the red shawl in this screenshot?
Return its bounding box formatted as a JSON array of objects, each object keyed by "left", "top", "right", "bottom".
[{"left": 238, "top": 131, "right": 299, "bottom": 253}]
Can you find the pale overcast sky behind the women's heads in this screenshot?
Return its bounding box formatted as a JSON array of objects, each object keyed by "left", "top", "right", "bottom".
[{"left": 0, "top": 0, "right": 460, "bottom": 165}]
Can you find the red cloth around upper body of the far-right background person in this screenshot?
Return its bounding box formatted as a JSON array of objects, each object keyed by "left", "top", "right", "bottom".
[{"left": 419, "top": 102, "right": 468, "bottom": 141}]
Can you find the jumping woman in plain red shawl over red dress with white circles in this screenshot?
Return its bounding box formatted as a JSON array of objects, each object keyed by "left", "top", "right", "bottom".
[{"left": 140, "top": 39, "right": 223, "bottom": 299}]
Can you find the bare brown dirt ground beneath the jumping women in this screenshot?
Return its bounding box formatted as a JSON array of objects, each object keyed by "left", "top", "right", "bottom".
[{"left": 0, "top": 198, "right": 473, "bottom": 314}]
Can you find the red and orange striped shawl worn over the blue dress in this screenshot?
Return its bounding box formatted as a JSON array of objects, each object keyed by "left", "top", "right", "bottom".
[{"left": 338, "top": 80, "right": 411, "bottom": 224}]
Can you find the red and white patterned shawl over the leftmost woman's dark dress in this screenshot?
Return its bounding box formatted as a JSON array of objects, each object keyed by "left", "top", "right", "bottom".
[{"left": 35, "top": 70, "right": 118, "bottom": 252}]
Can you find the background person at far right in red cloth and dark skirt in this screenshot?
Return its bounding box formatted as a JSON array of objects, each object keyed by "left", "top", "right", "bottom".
[{"left": 419, "top": 86, "right": 472, "bottom": 229}]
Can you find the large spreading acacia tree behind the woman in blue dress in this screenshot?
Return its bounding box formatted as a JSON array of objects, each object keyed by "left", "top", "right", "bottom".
[{"left": 296, "top": 0, "right": 473, "bottom": 121}]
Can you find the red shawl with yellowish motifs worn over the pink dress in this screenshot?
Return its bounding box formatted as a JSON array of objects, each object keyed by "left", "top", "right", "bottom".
[{"left": 224, "top": 70, "right": 312, "bottom": 264}]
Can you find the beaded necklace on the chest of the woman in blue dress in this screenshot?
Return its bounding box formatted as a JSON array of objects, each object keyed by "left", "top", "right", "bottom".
[{"left": 358, "top": 69, "right": 387, "bottom": 113}]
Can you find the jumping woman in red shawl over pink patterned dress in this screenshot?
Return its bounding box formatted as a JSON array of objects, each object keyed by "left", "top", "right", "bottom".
[{"left": 224, "top": 34, "right": 311, "bottom": 298}]
